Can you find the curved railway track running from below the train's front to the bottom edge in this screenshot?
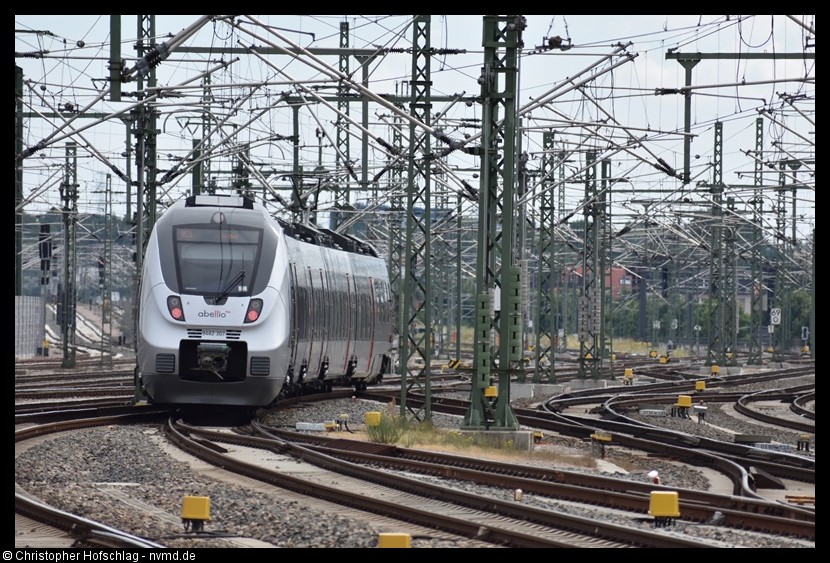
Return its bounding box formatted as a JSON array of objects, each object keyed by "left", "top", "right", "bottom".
[{"left": 165, "top": 423, "right": 711, "bottom": 547}]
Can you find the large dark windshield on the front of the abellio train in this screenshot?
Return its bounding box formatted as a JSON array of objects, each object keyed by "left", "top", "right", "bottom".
[{"left": 173, "top": 224, "right": 262, "bottom": 297}]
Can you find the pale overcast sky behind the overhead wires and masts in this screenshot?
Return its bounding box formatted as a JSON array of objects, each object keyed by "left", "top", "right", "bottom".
[{"left": 15, "top": 15, "right": 815, "bottom": 245}]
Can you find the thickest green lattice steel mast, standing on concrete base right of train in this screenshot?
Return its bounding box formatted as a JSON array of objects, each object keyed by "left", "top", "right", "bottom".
[{"left": 462, "top": 15, "right": 527, "bottom": 430}]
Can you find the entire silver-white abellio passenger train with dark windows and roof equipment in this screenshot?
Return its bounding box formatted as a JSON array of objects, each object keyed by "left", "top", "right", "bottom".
[{"left": 136, "top": 195, "right": 393, "bottom": 407}]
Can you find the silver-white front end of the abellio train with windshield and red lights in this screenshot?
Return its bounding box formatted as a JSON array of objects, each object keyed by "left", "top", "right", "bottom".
[{"left": 136, "top": 196, "right": 288, "bottom": 406}]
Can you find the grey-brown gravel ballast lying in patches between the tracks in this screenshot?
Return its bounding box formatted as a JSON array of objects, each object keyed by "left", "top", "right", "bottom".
[{"left": 15, "top": 378, "right": 815, "bottom": 548}]
